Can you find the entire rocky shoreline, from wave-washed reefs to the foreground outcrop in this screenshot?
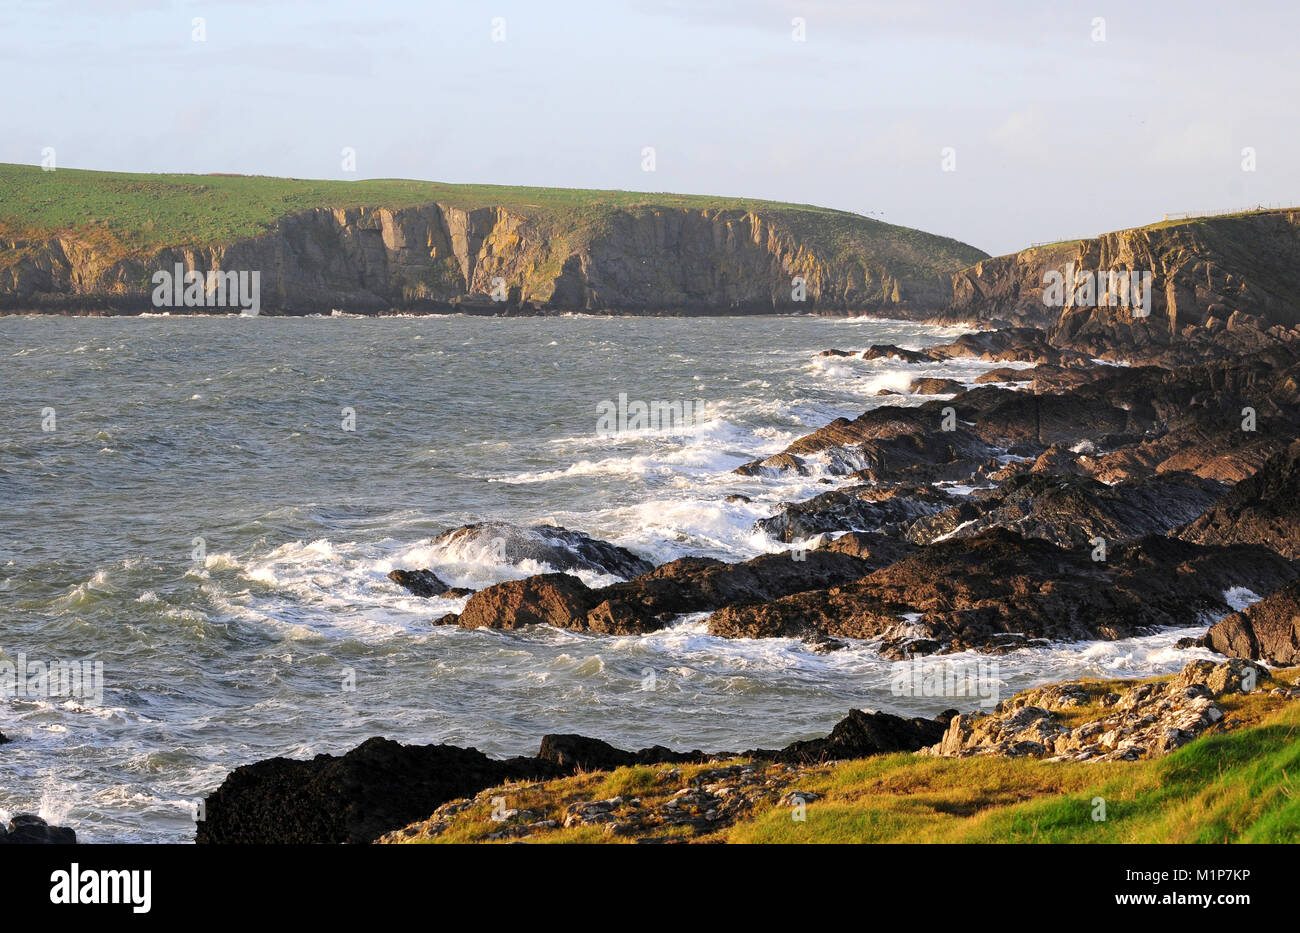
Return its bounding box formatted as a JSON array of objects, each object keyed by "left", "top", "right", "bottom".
[{"left": 196, "top": 314, "right": 1300, "bottom": 843}]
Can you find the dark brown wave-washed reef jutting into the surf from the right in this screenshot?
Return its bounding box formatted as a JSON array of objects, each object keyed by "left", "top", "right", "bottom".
[{"left": 379, "top": 324, "right": 1300, "bottom": 660}]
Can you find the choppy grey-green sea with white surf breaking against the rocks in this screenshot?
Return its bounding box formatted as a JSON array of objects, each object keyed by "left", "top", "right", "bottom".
[{"left": 0, "top": 314, "right": 1222, "bottom": 842}]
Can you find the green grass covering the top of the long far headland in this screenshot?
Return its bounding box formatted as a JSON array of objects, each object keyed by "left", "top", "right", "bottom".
[{"left": 0, "top": 164, "right": 985, "bottom": 275}]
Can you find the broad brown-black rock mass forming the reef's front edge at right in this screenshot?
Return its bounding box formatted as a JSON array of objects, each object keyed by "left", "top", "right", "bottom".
[{"left": 707, "top": 529, "right": 1297, "bottom": 656}]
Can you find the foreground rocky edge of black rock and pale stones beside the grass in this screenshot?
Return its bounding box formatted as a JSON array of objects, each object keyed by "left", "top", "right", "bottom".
[{"left": 188, "top": 660, "right": 1300, "bottom": 845}]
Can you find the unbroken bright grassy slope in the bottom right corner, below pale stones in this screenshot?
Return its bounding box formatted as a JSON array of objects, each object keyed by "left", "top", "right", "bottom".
[{"left": 727, "top": 702, "right": 1300, "bottom": 843}]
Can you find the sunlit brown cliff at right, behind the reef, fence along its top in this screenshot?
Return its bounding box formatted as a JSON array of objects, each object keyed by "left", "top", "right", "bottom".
[{"left": 946, "top": 209, "right": 1300, "bottom": 352}]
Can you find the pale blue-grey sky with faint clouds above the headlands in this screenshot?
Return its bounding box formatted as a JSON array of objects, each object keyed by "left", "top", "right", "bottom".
[{"left": 0, "top": 0, "right": 1300, "bottom": 255}]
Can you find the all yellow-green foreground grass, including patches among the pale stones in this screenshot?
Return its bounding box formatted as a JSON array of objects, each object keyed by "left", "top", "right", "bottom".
[{"left": 387, "top": 668, "right": 1300, "bottom": 843}]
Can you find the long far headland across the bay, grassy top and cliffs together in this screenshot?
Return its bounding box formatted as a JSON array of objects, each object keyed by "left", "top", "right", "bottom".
[{"left": 0, "top": 166, "right": 983, "bottom": 314}]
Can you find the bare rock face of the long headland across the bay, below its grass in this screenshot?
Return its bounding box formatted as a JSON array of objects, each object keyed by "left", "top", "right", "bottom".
[{"left": 0, "top": 203, "right": 979, "bottom": 313}]
